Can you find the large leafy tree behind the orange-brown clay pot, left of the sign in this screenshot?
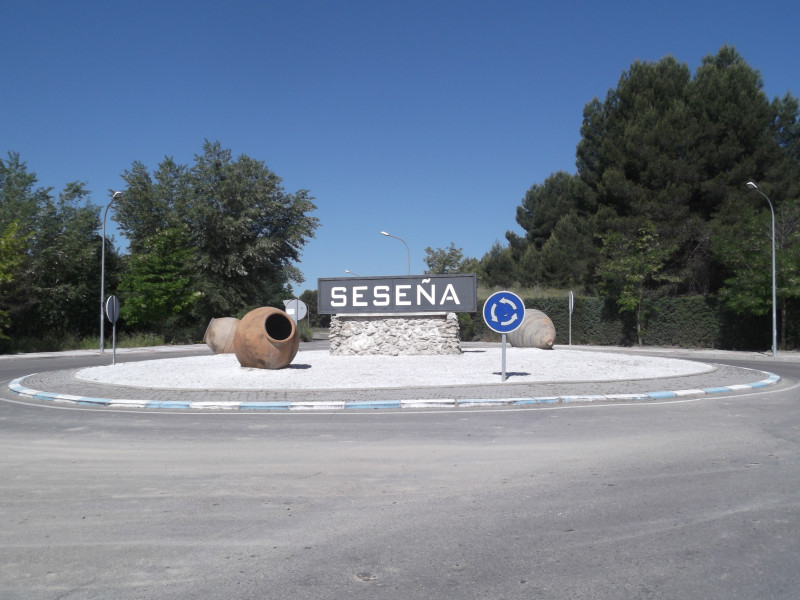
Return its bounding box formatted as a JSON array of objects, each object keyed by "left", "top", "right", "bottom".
[{"left": 116, "top": 141, "right": 319, "bottom": 332}]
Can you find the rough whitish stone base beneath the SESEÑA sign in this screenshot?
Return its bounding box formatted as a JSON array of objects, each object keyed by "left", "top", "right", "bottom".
[{"left": 330, "top": 313, "right": 461, "bottom": 356}]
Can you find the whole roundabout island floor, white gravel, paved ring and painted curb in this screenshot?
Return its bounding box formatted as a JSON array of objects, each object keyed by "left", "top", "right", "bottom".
[{"left": 8, "top": 345, "right": 780, "bottom": 411}]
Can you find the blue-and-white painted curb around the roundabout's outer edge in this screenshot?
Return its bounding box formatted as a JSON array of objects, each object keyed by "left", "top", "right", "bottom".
[{"left": 8, "top": 370, "right": 781, "bottom": 412}]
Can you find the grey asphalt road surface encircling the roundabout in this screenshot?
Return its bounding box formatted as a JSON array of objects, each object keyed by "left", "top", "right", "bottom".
[{"left": 0, "top": 346, "right": 800, "bottom": 600}]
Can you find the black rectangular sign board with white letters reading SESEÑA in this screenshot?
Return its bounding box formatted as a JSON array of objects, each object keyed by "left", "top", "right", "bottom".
[{"left": 317, "top": 273, "right": 478, "bottom": 315}]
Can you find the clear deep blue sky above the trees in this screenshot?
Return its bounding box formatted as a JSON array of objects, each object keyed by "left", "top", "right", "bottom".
[{"left": 0, "top": 0, "right": 800, "bottom": 293}]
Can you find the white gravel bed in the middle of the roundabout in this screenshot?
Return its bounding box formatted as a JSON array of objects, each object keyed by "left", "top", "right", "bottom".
[{"left": 76, "top": 347, "right": 714, "bottom": 390}]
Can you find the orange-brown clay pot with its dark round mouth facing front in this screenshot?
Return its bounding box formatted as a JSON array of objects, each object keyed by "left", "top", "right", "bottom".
[{"left": 238, "top": 306, "right": 300, "bottom": 369}]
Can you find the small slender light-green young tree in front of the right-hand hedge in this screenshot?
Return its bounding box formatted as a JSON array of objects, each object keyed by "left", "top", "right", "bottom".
[{"left": 598, "top": 221, "right": 677, "bottom": 346}]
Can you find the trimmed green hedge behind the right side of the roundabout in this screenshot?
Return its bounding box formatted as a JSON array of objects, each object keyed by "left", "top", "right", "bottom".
[{"left": 459, "top": 296, "right": 800, "bottom": 350}]
